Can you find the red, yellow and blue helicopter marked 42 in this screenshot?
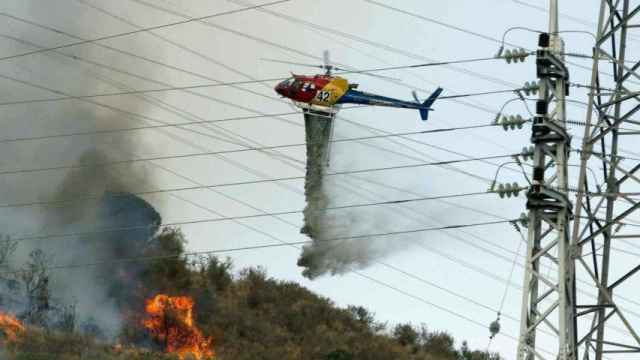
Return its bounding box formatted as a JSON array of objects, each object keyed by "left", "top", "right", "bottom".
[{"left": 264, "top": 51, "right": 442, "bottom": 121}]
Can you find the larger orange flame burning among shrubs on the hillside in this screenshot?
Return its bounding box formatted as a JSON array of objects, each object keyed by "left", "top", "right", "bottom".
[{"left": 142, "top": 294, "right": 214, "bottom": 359}]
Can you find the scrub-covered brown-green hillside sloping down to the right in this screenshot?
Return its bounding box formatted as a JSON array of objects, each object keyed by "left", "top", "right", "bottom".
[{"left": 3, "top": 229, "right": 499, "bottom": 360}]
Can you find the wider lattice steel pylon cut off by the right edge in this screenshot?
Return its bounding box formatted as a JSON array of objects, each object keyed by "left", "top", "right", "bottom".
[{"left": 572, "top": 0, "right": 640, "bottom": 360}]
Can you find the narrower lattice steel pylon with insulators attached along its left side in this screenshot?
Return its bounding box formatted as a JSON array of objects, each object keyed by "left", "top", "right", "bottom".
[{"left": 518, "top": 0, "right": 576, "bottom": 360}]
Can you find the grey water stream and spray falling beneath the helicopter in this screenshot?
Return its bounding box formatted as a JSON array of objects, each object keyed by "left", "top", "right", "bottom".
[{"left": 298, "top": 114, "right": 406, "bottom": 279}]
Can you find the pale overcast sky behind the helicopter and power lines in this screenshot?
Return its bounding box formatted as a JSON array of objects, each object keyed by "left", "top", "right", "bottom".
[{"left": 0, "top": 0, "right": 640, "bottom": 359}]
